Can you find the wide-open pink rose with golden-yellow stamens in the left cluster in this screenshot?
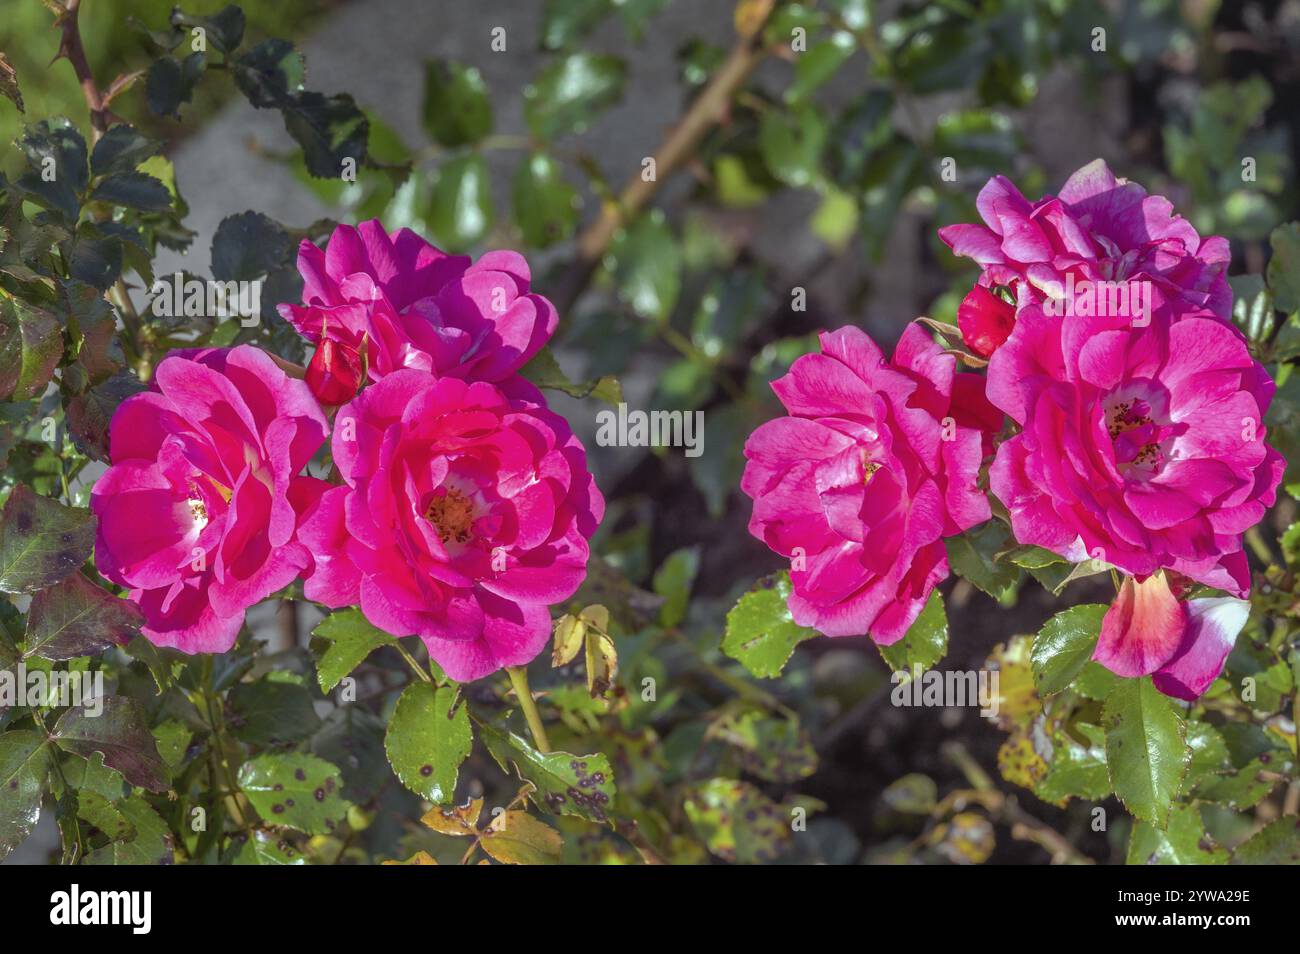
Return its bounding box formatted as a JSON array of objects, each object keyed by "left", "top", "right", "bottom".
[{"left": 299, "top": 369, "right": 605, "bottom": 681}]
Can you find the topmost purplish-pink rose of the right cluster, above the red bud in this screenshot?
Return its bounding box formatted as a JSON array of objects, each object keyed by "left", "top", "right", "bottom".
[{"left": 939, "top": 159, "right": 1232, "bottom": 335}]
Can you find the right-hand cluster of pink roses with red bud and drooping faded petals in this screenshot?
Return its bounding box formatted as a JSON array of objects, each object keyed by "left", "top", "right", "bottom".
[{"left": 742, "top": 160, "right": 1284, "bottom": 699}]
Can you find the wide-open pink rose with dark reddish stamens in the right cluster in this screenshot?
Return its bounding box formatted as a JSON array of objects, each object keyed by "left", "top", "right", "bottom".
[{"left": 988, "top": 290, "right": 1284, "bottom": 597}]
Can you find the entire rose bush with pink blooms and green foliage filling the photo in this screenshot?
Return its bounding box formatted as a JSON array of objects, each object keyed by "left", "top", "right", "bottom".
[{"left": 0, "top": 0, "right": 1300, "bottom": 873}]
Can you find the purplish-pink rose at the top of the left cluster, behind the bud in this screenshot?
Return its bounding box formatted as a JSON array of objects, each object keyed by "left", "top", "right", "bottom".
[{"left": 280, "top": 220, "right": 558, "bottom": 381}]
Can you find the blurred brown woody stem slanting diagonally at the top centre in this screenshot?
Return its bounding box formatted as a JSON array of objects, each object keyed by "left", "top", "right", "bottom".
[{"left": 555, "top": 4, "right": 779, "bottom": 315}]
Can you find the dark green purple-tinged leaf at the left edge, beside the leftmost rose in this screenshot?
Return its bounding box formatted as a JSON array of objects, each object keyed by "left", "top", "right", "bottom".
[{"left": 0, "top": 483, "right": 95, "bottom": 593}]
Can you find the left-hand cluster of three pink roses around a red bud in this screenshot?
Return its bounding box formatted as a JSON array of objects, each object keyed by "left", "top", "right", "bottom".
[{"left": 91, "top": 221, "right": 605, "bottom": 681}]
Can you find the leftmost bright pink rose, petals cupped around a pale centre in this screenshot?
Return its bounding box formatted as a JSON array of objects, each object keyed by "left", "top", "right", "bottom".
[{"left": 90, "top": 344, "right": 328, "bottom": 652}]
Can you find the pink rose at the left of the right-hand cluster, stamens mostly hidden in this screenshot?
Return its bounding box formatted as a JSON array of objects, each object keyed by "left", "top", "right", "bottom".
[{"left": 741, "top": 324, "right": 1001, "bottom": 645}]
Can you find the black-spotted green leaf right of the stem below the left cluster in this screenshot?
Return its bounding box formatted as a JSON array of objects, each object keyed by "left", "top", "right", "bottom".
[{"left": 480, "top": 725, "right": 618, "bottom": 821}]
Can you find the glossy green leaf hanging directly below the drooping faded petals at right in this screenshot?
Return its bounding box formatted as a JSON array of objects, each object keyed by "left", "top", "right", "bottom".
[{"left": 1101, "top": 676, "right": 1190, "bottom": 829}]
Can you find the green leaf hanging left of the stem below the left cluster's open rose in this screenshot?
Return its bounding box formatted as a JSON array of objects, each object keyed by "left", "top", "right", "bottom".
[{"left": 384, "top": 682, "right": 473, "bottom": 805}]
